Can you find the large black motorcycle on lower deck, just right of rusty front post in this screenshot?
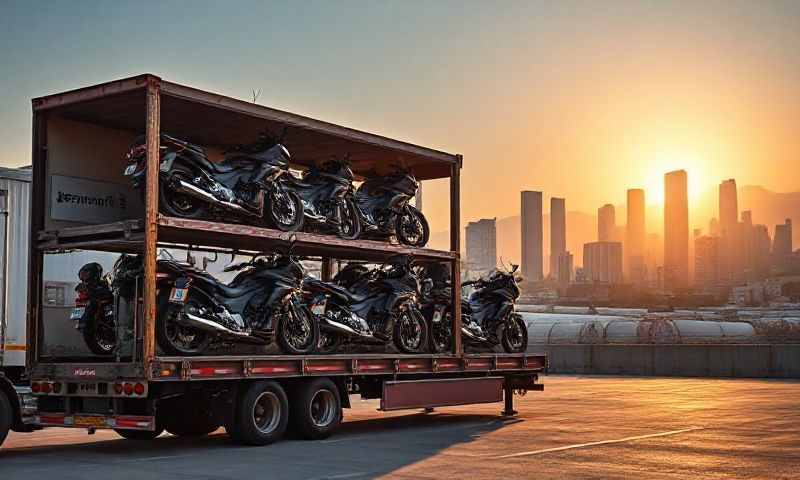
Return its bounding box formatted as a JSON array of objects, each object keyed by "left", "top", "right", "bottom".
[{"left": 156, "top": 242, "right": 319, "bottom": 355}]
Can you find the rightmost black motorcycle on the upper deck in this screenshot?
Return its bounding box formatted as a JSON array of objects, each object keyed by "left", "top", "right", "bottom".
[{"left": 354, "top": 170, "right": 430, "bottom": 247}]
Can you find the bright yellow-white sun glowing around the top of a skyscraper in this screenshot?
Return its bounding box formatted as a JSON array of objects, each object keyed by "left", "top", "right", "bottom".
[{"left": 644, "top": 151, "right": 706, "bottom": 205}]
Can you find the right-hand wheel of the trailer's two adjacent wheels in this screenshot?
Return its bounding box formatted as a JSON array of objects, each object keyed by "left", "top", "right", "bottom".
[{"left": 291, "top": 378, "right": 342, "bottom": 440}]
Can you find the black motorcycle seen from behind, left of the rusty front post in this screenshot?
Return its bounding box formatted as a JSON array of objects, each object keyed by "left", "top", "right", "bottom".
[{"left": 70, "top": 254, "right": 142, "bottom": 355}]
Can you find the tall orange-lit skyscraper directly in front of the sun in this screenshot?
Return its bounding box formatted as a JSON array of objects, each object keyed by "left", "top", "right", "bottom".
[{"left": 664, "top": 170, "right": 689, "bottom": 290}]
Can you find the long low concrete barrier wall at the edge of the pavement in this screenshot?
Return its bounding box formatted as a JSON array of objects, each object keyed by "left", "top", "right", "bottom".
[{"left": 528, "top": 344, "right": 800, "bottom": 378}]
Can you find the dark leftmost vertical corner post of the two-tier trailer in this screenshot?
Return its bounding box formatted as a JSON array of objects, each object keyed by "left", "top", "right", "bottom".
[{"left": 25, "top": 110, "right": 49, "bottom": 368}]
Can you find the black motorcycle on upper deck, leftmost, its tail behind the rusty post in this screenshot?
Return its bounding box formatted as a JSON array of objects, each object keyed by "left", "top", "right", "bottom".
[{"left": 124, "top": 134, "right": 303, "bottom": 231}]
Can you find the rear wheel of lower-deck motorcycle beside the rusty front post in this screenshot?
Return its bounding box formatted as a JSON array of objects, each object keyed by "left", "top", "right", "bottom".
[{"left": 156, "top": 290, "right": 212, "bottom": 355}]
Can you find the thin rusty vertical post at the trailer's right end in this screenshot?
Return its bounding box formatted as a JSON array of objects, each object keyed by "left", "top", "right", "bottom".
[{"left": 450, "top": 155, "right": 464, "bottom": 356}]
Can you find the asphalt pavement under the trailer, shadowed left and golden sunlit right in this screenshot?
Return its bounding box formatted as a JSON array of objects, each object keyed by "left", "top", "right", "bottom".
[{"left": 0, "top": 376, "right": 800, "bottom": 480}]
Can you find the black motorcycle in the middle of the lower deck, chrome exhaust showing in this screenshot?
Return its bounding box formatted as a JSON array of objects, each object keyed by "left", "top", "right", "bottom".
[{"left": 304, "top": 257, "right": 428, "bottom": 353}]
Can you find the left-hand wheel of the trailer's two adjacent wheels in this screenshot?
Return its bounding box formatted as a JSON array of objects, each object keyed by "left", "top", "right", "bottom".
[{"left": 225, "top": 381, "right": 289, "bottom": 445}]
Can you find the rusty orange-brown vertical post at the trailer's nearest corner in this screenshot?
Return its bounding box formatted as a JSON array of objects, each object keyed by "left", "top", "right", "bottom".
[{"left": 142, "top": 77, "right": 161, "bottom": 378}]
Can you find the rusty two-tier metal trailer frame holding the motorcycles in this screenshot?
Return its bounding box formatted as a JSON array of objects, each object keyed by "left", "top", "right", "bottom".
[{"left": 27, "top": 74, "right": 547, "bottom": 436}]
